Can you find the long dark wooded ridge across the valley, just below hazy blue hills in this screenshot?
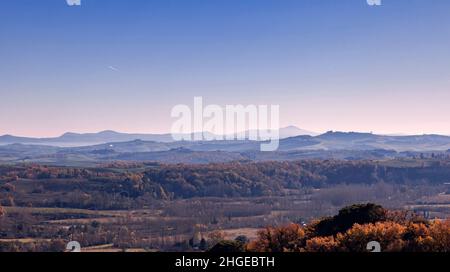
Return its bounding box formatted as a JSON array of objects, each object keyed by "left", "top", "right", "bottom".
[{"left": 0, "top": 160, "right": 450, "bottom": 206}]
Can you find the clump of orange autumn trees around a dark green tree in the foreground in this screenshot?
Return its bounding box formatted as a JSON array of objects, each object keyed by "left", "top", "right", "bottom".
[{"left": 246, "top": 204, "right": 450, "bottom": 252}]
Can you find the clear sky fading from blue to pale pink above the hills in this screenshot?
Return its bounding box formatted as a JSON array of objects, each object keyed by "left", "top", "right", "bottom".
[{"left": 0, "top": 0, "right": 450, "bottom": 137}]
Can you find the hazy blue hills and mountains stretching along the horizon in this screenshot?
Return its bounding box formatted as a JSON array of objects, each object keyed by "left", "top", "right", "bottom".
[{"left": 0, "top": 127, "right": 450, "bottom": 165}]
